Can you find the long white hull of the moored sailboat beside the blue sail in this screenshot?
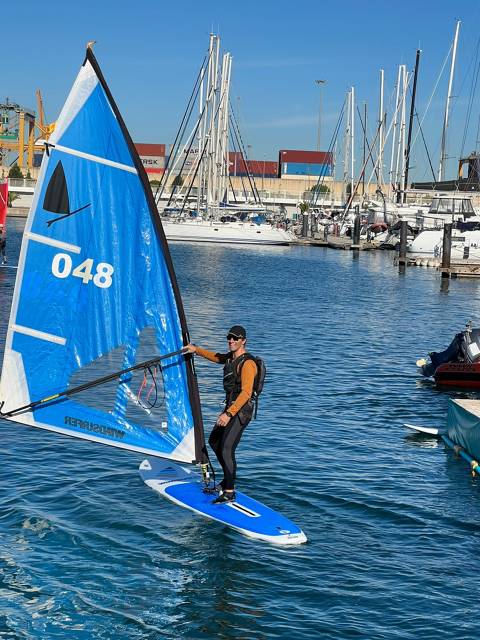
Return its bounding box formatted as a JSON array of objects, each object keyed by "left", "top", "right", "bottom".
[{"left": 162, "top": 218, "right": 295, "bottom": 245}]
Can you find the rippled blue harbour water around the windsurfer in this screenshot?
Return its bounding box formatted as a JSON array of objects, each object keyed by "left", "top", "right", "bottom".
[{"left": 0, "top": 220, "right": 480, "bottom": 640}]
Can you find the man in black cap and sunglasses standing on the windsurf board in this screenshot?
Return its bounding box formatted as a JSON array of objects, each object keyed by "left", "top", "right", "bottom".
[{"left": 187, "top": 325, "right": 258, "bottom": 504}]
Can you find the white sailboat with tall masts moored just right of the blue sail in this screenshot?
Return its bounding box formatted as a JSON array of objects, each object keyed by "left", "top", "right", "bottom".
[{"left": 156, "top": 34, "right": 295, "bottom": 245}]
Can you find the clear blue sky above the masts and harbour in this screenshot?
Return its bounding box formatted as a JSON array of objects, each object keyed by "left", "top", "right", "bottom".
[{"left": 0, "top": 0, "right": 480, "bottom": 180}]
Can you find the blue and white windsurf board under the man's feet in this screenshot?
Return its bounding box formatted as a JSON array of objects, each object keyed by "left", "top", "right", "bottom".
[{"left": 140, "top": 458, "right": 307, "bottom": 545}]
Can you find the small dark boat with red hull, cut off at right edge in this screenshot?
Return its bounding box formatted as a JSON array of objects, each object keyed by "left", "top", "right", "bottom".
[{"left": 416, "top": 322, "right": 480, "bottom": 389}]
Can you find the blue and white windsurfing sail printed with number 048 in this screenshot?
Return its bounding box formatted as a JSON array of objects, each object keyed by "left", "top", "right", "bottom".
[{"left": 0, "top": 49, "right": 205, "bottom": 463}]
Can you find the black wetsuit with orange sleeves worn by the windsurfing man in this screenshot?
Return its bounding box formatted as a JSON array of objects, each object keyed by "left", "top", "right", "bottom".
[{"left": 197, "top": 347, "right": 257, "bottom": 491}]
